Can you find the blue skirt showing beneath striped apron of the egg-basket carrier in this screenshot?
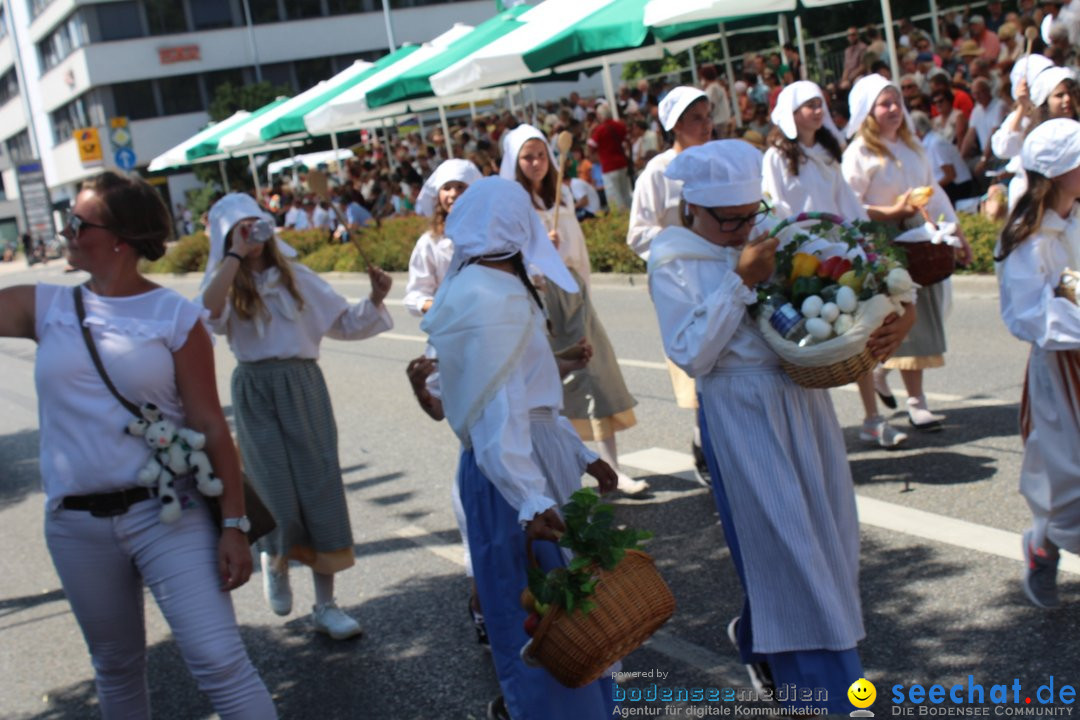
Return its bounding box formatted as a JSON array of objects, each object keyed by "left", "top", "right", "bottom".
[{"left": 698, "top": 395, "right": 864, "bottom": 715}]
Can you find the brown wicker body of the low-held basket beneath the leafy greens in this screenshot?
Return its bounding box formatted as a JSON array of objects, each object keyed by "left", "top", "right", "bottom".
[{"left": 522, "top": 549, "right": 675, "bottom": 688}]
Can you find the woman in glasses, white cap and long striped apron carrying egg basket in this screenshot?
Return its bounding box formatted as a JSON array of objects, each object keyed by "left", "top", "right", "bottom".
[{"left": 649, "top": 140, "right": 900, "bottom": 714}]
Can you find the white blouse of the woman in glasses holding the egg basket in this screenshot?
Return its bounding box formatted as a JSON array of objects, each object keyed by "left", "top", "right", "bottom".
[{"left": 649, "top": 227, "right": 780, "bottom": 378}]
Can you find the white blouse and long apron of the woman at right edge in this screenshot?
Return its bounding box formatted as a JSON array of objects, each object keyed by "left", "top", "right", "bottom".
[{"left": 997, "top": 209, "right": 1080, "bottom": 553}]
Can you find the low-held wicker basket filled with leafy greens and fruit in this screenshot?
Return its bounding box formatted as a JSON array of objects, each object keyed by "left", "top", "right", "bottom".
[{"left": 522, "top": 489, "right": 675, "bottom": 688}]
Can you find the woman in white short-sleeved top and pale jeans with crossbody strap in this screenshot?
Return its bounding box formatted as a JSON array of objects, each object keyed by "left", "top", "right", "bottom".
[{"left": 0, "top": 173, "right": 276, "bottom": 720}]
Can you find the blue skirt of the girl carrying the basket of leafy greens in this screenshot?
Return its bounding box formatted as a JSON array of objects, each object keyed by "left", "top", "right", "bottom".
[{"left": 458, "top": 449, "right": 616, "bottom": 720}]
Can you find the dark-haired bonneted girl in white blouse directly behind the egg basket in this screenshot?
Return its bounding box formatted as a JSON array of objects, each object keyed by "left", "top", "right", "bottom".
[{"left": 761, "top": 80, "right": 907, "bottom": 448}]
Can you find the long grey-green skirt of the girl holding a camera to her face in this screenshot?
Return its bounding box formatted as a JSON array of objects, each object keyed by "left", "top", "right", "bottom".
[{"left": 232, "top": 359, "right": 354, "bottom": 573}]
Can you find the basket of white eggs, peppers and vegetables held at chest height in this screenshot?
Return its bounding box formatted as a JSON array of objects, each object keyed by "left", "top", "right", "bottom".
[{"left": 755, "top": 213, "right": 917, "bottom": 388}]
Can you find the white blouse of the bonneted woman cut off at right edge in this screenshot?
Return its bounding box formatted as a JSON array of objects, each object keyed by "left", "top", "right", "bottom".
[{"left": 997, "top": 209, "right": 1080, "bottom": 350}]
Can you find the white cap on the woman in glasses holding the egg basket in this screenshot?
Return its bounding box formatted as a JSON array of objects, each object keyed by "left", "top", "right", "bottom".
[{"left": 664, "top": 140, "right": 761, "bottom": 207}]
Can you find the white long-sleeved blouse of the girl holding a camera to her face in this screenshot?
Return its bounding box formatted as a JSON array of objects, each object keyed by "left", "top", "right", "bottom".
[{"left": 210, "top": 262, "right": 394, "bottom": 363}]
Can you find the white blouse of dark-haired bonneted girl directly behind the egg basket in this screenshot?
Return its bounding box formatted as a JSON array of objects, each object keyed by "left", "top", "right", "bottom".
[{"left": 761, "top": 145, "right": 868, "bottom": 220}]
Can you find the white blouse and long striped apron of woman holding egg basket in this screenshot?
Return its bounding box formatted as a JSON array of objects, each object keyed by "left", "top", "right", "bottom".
[{"left": 649, "top": 228, "right": 865, "bottom": 653}]
